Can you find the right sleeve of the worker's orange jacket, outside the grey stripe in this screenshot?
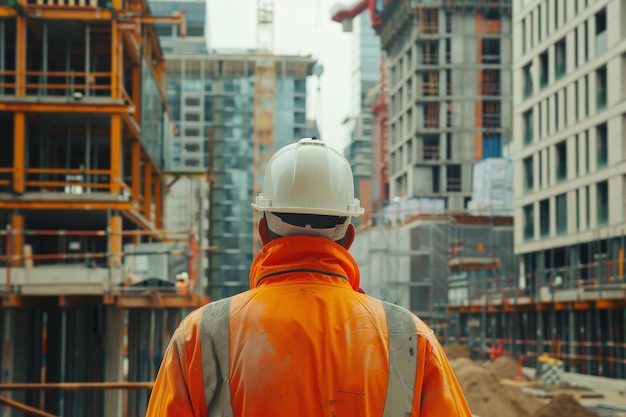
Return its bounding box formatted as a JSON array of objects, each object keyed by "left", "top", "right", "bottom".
[{"left": 412, "top": 323, "right": 472, "bottom": 417}]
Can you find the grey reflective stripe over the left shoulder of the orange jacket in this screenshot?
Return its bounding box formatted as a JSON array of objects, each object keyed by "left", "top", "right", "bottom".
[{"left": 200, "top": 298, "right": 233, "bottom": 417}]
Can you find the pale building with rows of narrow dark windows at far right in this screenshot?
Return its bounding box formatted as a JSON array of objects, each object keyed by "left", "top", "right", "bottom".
[{"left": 513, "top": 0, "right": 626, "bottom": 286}]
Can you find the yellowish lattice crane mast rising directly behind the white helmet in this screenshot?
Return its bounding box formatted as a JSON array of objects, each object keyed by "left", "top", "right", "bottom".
[{"left": 252, "top": 0, "right": 276, "bottom": 256}]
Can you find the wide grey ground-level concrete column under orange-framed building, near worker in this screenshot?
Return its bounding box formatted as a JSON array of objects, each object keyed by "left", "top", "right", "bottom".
[{"left": 104, "top": 306, "right": 124, "bottom": 417}]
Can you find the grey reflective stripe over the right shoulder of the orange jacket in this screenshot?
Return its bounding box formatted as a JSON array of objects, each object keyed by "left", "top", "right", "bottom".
[{"left": 383, "top": 302, "right": 417, "bottom": 417}]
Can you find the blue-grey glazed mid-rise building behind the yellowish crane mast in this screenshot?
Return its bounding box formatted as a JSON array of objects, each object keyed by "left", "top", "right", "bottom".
[{"left": 166, "top": 51, "right": 315, "bottom": 299}]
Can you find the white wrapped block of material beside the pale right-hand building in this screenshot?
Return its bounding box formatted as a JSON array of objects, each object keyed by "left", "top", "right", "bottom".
[{"left": 468, "top": 158, "right": 513, "bottom": 216}]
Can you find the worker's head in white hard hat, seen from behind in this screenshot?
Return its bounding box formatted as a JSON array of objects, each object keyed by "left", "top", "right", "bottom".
[{"left": 252, "top": 138, "right": 364, "bottom": 247}]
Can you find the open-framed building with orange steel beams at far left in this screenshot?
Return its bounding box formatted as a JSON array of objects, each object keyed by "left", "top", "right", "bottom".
[{"left": 0, "top": 0, "right": 206, "bottom": 416}]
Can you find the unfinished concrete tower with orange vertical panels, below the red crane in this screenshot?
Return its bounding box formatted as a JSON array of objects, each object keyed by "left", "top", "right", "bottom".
[{"left": 378, "top": 1, "right": 511, "bottom": 210}]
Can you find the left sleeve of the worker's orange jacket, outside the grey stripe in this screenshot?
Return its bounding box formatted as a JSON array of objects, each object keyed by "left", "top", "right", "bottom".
[{"left": 146, "top": 313, "right": 207, "bottom": 417}]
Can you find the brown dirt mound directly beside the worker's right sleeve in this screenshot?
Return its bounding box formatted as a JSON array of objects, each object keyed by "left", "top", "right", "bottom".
[{"left": 450, "top": 358, "right": 540, "bottom": 417}]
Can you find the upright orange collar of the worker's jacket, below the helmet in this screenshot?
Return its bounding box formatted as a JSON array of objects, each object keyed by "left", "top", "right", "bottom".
[{"left": 250, "top": 236, "right": 360, "bottom": 290}]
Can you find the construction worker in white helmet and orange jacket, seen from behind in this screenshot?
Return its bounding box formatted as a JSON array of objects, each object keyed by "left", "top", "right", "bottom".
[{"left": 147, "top": 138, "right": 471, "bottom": 417}]
